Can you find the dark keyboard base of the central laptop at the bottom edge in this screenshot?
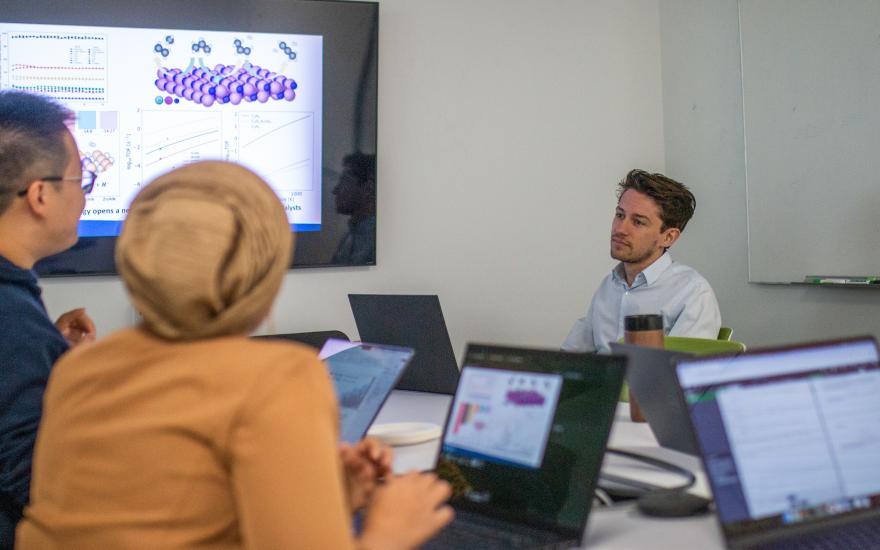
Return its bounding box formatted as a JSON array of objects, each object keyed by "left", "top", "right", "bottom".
[{"left": 422, "top": 512, "right": 579, "bottom": 550}]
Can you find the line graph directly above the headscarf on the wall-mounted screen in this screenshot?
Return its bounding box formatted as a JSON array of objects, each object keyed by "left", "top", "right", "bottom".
[{"left": 141, "top": 111, "right": 223, "bottom": 181}]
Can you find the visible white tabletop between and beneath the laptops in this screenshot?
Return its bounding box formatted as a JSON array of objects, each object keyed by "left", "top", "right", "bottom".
[{"left": 375, "top": 390, "right": 724, "bottom": 550}]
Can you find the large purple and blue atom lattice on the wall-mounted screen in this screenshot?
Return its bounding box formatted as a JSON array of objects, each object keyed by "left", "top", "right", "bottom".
[{"left": 155, "top": 63, "right": 297, "bottom": 107}]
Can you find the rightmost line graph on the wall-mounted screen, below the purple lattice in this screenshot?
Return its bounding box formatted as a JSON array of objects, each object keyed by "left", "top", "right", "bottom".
[{"left": 234, "top": 111, "right": 315, "bottom": 191}]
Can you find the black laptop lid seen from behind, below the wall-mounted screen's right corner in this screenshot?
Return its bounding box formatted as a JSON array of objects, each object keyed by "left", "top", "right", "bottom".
[{"left": 348, "top": 294, "right": 458, "bottom": 394}]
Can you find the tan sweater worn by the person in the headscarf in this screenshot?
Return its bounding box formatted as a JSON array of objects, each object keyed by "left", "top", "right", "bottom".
[{"left": 16, "top": 329, "right": 354, "bottom": 550}]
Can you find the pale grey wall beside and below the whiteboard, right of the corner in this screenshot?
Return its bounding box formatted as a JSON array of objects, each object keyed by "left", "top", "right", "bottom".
[{"left": 660, "top": 0, "right": 880, "bottom": 346}]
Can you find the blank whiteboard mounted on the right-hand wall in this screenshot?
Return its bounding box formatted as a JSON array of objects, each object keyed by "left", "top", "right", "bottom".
[{"left": 739, "top": 0, "right": 880, "bottom": 283}]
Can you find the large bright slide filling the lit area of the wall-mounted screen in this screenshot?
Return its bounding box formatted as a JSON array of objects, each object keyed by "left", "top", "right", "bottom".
[{"left": 0, "top": 21, "right": 323, "bottom": 237}]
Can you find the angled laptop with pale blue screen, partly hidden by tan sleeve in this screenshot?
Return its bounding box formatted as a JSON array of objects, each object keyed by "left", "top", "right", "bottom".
[{"left": 320, "top": 339, "right": 414, "bottom": 443}]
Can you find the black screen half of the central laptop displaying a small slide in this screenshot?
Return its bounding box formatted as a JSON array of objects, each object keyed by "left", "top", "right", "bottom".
[{"left": 423, "top": 344, "right": 626, "bottom": 549}]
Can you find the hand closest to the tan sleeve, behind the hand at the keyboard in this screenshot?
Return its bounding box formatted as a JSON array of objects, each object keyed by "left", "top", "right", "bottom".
[{"left": 339, "top": 437, "right": 392, "bottom": 511}]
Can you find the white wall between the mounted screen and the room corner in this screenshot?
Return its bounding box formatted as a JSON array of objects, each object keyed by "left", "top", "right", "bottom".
[{"left": 43, "top": 0, "right": 660, "bottom": 360}]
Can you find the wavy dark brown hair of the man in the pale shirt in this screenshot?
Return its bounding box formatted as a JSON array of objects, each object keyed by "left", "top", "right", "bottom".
[{"left": 617, "top": 169, "right": 697, "bottom": 231}]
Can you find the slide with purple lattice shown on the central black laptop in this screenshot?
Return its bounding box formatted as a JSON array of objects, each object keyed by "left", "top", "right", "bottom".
[{"left": 444, "top": 367, "right": 562, "bottom": 468}]
